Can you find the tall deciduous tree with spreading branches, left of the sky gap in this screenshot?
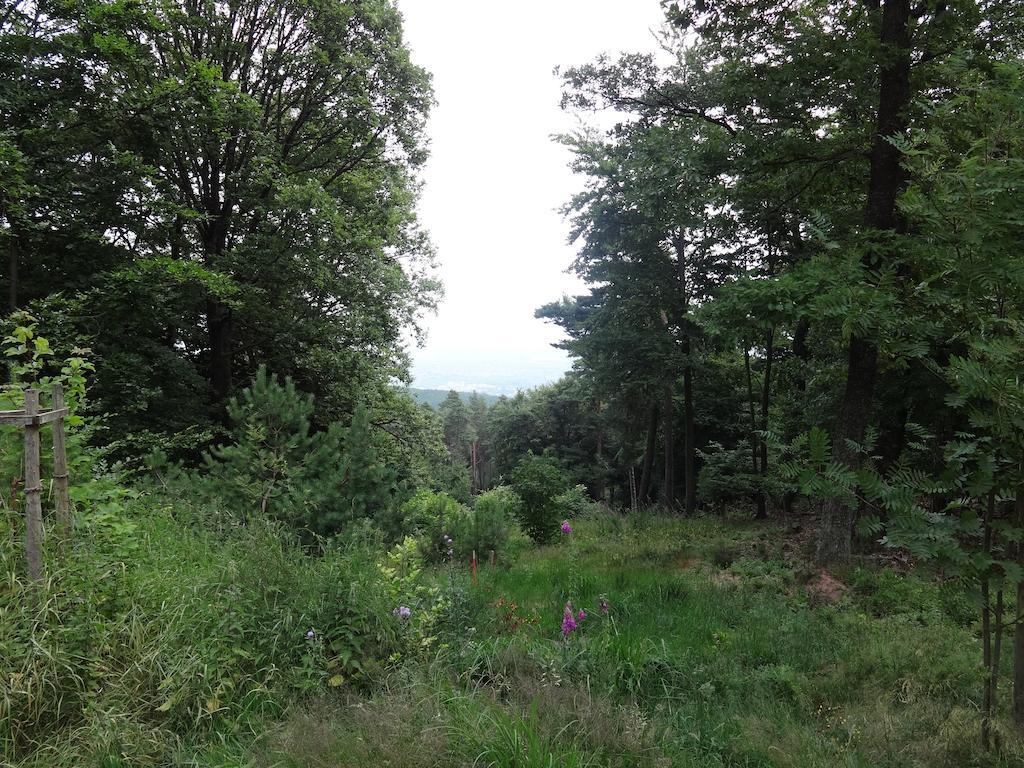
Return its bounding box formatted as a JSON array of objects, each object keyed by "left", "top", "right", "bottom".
[{"left": 113, "top": 0, "right": 430, "bottom": 411}]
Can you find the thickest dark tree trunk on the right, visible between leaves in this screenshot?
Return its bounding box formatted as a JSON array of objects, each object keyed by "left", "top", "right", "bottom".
[{"left": 817, "top": 0, "right": 910, "bottom": 563}]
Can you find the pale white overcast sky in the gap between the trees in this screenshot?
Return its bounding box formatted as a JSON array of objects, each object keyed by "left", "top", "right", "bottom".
[{"left": 398, "top": 0, "right": 662, "bottom": 394}]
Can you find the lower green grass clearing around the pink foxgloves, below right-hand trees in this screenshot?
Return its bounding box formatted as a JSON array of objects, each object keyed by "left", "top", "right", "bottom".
[{"left": 256, "top": 517, "right": 1024, "bottom": 768}]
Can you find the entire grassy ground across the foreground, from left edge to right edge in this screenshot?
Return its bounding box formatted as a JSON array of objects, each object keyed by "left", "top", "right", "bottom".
[{"left": 0, "top": 504, "right": 1024, "bottom": 768}]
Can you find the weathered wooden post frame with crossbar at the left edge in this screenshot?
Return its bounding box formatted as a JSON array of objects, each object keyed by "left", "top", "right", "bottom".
[{"left": 0, "top": 384, "right": 71, "bottom": 582}]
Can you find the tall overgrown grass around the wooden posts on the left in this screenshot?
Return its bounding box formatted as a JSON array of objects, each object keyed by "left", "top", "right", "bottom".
[{"left": 0, "top": 500, "right": 395, "bottom": 766}]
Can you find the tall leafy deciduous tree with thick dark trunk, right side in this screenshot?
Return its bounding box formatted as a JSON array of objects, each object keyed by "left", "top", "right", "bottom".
[{"left": 552, "top": 0, "right": 1016, "bottom": 561}]
